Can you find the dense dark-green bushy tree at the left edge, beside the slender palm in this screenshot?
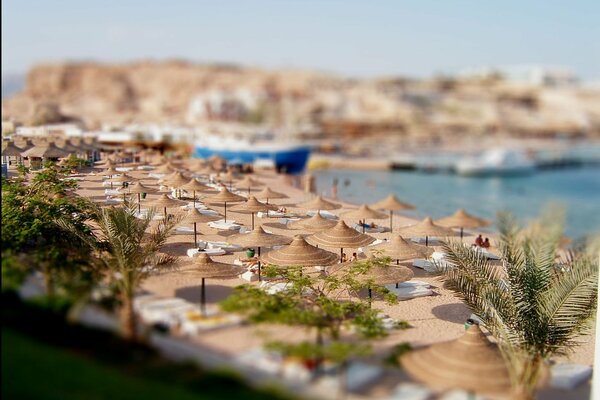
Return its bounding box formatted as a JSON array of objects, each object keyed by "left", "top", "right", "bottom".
[{"left": 2, "top": 163, "right": 96, "bottom": 301}]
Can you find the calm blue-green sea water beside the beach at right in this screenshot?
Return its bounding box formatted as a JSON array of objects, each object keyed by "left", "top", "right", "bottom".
[{"left": 314, "top": 167, "right": 600, "bottom": 238}]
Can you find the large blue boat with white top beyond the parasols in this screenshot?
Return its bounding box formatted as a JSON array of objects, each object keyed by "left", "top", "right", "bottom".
[{"left": 194, "top": 143, "right": 311, "bottom": 174}]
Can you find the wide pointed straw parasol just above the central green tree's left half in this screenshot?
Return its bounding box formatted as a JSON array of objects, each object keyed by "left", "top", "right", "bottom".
[{"left": 261, "top": 231, "right": 340, "bottom": 267}]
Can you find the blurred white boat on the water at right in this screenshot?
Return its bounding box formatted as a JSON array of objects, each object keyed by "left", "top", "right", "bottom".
[{"left": 454, "top": 149, "right": 536, "bottom": 176}]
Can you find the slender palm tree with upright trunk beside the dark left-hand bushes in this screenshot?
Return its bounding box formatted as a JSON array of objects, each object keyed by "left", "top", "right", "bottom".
[{"left": 66, "top": 206, "right": 178, "bottom": 340}]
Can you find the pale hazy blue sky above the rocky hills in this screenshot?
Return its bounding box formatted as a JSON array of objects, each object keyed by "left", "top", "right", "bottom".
[{"left": 2, "top": 0, "right": 600, "bottom": 79}]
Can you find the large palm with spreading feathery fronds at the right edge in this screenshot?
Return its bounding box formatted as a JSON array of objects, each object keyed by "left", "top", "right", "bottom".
[{"left": 440, "top": 213, "right": 598, "bottom": 399}]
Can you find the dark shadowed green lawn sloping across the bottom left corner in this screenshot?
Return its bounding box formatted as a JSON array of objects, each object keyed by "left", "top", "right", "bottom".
[{"left": 2, "top": 329, "right": 234, "bottom": 400}]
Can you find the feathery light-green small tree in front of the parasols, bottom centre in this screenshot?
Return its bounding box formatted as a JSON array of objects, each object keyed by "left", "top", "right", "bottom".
[{"left": 221, "top": 258, "right": 406, "bottom": 376}]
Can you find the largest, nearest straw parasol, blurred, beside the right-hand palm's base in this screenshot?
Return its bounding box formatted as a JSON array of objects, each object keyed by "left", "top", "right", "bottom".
[{"left": 401, "top": 325, "right": 511, "bottom": 395}]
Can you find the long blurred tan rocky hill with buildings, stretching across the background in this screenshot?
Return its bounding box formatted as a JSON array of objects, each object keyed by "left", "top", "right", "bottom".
[{"left": 2, "top": 61, "right": 600, "bottom": 139}]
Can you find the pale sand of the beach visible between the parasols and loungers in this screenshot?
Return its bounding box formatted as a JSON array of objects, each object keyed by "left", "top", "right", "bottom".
[{"left": 64, "top": 164, "right": 595, "bottom": 397}]
